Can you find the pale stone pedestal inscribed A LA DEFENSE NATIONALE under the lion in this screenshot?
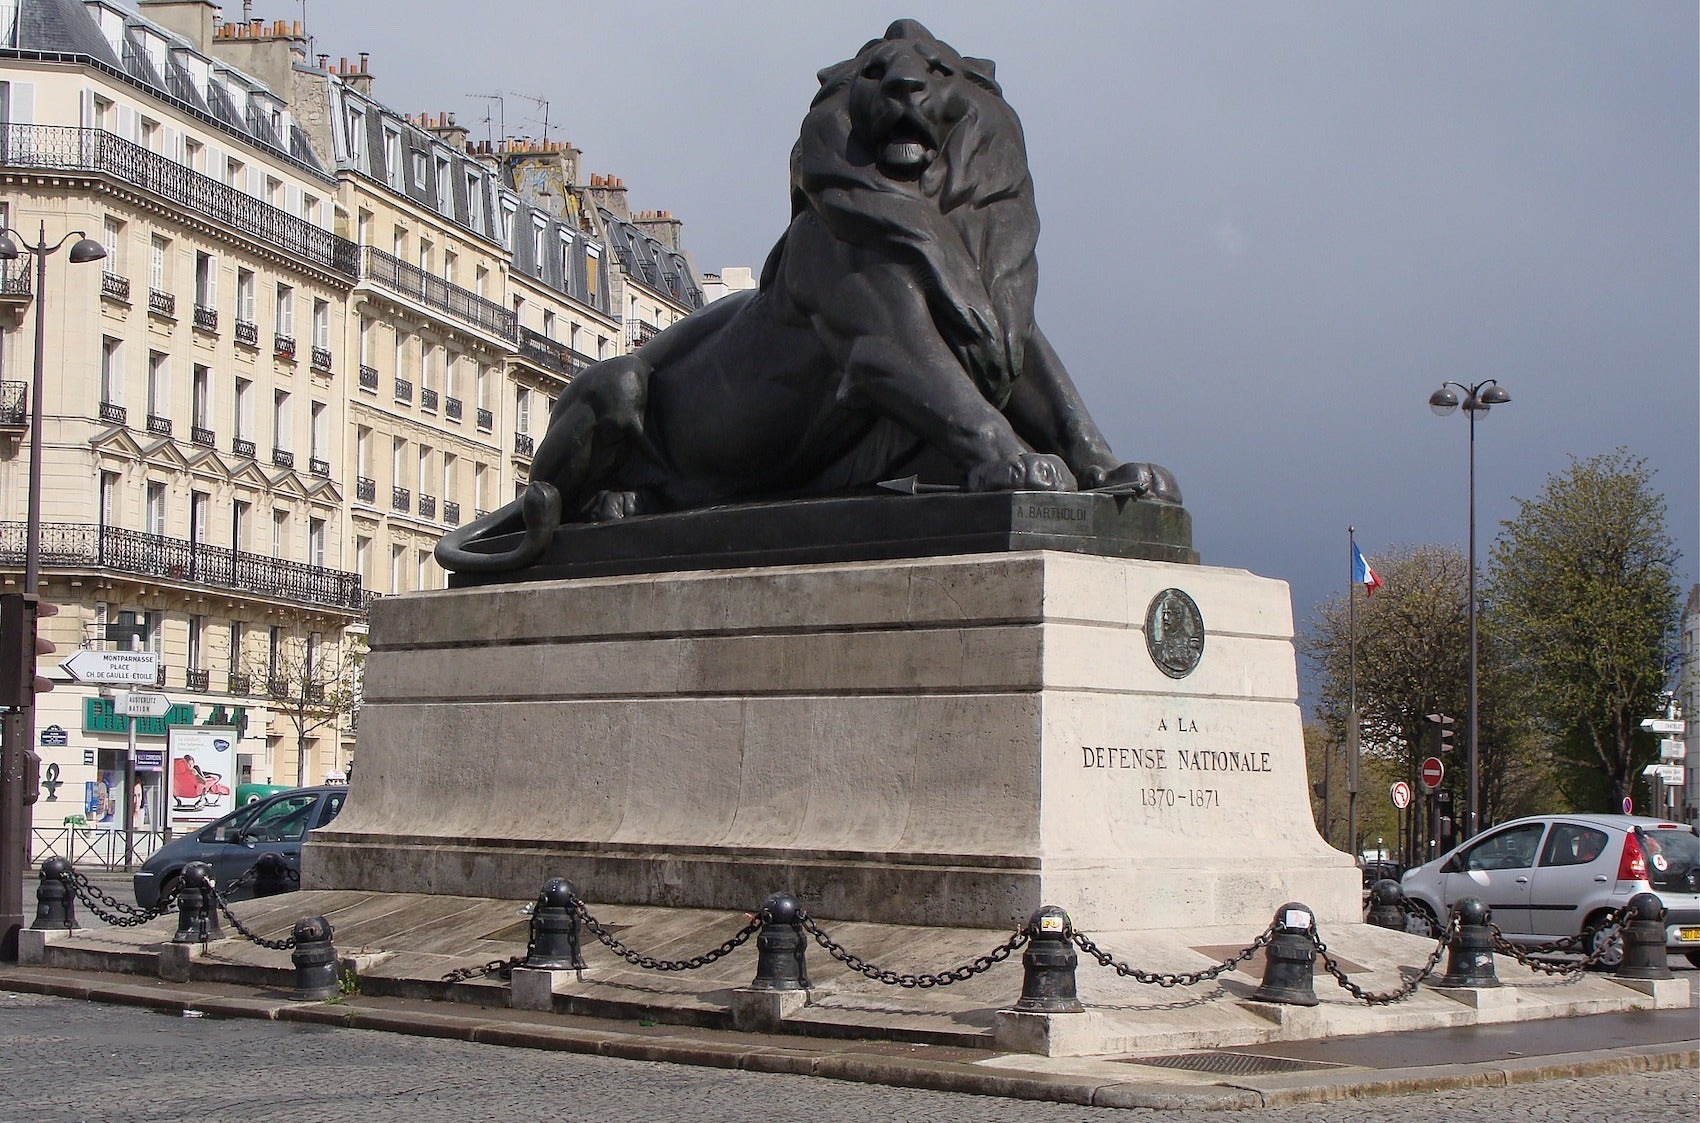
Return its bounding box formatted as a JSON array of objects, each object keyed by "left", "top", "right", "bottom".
[{"left": 303, "top": 550, "right": 1360, "bottom": 933}]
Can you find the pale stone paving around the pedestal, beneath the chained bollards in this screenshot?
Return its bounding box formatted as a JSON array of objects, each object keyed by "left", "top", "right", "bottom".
[{"left": 0, "top": 890, "right": 1700, "bottom": 1108}]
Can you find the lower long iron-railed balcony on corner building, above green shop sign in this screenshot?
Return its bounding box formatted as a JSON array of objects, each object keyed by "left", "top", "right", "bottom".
[{"left": 0, "top": 522, "right": 362, "bottom": 608}]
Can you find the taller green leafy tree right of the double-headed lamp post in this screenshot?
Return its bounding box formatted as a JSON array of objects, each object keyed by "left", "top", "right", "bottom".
[{"left": 1484, "top": 449, "right": 1681, "bottom": 810}]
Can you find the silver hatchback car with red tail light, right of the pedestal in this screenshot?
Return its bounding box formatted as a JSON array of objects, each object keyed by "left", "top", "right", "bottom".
[{"left": 1401, "top": 815, "right": 1700, "bottom": 968}]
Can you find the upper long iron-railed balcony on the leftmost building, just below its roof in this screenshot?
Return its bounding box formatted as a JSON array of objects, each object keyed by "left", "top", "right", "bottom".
[{"left": 0, "top": 124, "right": 359, "bottom": 279}]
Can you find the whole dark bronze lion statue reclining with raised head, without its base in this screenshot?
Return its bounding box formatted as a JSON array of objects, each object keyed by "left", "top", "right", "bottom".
[{"left": 437, "top": 20, "right": 1180, "bottom": 573}]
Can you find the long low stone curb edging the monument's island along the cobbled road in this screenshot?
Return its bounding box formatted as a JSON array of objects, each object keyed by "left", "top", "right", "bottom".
[{"left": 0, "top": 968, "right": 1700, "bottom": 1111}]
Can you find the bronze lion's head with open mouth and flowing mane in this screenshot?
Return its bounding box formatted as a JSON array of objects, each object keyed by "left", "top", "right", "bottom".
[{"left": 791, "top": 20, "right": 1039, "bottom": 401}]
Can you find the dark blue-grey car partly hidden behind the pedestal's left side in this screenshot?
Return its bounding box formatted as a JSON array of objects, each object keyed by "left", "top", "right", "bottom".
[{"left": 136, "top": 785, "right": 349, "bottom": 909}]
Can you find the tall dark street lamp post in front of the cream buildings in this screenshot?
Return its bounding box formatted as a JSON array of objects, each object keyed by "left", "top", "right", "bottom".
[{"left": 0, "top": 223, "right": 105, "bottom": 958}]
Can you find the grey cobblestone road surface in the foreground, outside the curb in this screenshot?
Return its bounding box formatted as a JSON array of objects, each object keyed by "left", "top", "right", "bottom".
[{"left": 0, "top": 992, "right": 1700, "bottom": 1123}]
